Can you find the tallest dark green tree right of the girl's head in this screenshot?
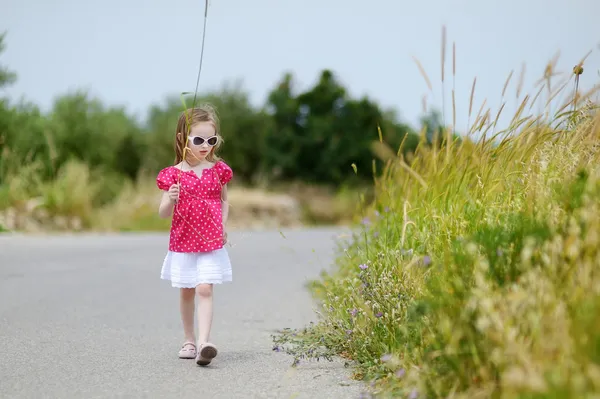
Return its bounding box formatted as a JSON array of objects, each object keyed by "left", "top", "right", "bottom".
[{"left": 267, "top": 70, "right": 416, "bottom": 184}]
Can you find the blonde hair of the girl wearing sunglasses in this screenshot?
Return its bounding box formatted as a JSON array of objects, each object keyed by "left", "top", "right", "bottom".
[{"left": 175, "top": 104, "right": 223, "bottom": 164}]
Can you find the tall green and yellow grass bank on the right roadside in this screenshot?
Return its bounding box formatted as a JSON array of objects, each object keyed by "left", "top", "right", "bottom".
[{"left": 273, "top": 46, "right": 600, "bottom": 399}]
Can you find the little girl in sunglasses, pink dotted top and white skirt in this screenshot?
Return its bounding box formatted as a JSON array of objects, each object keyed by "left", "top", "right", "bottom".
[{"left": 156, "top": 105, "right": 233, "bottom": 366}]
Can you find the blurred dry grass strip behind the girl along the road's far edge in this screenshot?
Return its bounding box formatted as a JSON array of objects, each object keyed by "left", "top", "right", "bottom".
[{"left": 0, "top": 152, "right": 355, "bottom": 232}]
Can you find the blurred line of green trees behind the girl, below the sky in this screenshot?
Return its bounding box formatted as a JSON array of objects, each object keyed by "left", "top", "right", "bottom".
[{"left": 0, "top": 36, "right": 440, "bottom": 195}]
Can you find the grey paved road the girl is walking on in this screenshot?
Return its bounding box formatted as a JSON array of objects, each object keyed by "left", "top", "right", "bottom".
[{"left": 0, "top": 229, "right": 360, "bottom": 399}]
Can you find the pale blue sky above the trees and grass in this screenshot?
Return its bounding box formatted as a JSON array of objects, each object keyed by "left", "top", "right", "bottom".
[{"left": 0, "top": 0, "right": 600, "bottom": 133}]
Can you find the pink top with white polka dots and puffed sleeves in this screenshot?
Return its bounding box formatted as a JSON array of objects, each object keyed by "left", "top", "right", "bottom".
[{"left": 156, "top": 161, "right": 233, "bottom": 252}]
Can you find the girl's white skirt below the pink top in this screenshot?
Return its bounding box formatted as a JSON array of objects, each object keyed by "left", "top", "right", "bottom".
[{"left": 160, "top": 248, "right": 232, "bottom": 288}]
